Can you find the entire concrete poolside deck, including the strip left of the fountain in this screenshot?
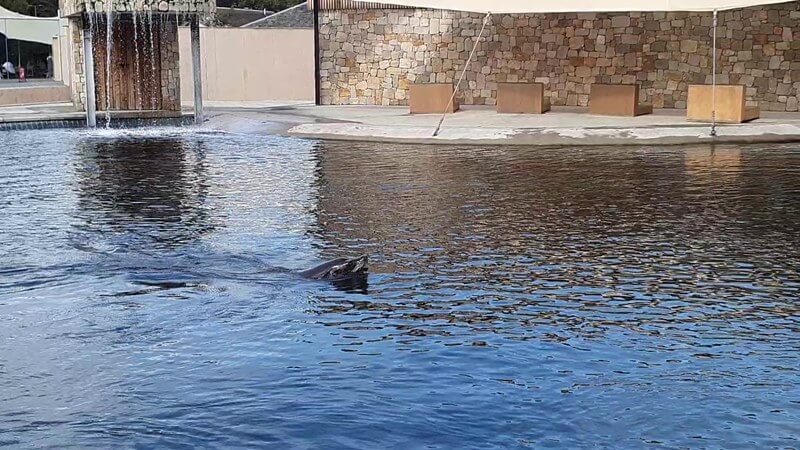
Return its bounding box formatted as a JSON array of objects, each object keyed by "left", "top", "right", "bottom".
[{"left": 6, "top": 102, "right": 800, "bottom": 145}]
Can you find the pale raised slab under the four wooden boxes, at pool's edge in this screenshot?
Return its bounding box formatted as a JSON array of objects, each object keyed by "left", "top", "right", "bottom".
[{"left": 272, "top": 106, "right": 800, "bottom": 145}]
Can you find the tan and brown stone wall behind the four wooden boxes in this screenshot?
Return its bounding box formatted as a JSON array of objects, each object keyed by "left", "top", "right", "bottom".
[{"left": 320, "top": 2, "right": 800, "bottom": 111}]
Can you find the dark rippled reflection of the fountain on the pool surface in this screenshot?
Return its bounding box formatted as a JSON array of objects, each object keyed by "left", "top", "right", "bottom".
[{"left": 74, "top": 137, "right": 215, "bottom": 247}]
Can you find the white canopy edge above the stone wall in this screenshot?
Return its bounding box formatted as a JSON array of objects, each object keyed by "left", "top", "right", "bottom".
[{"left": 356, "top": 0, "right": 788, "bottom": 14}]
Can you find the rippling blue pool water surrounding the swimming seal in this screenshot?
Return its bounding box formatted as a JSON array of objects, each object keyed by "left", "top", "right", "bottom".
[{"left": 0, "top": 130, "right": 800, "bottom": 449}]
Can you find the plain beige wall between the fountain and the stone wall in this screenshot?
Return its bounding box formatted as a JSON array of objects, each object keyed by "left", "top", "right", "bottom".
[{"left": 179, "top": 28, "right": 314, "bottom": 105}]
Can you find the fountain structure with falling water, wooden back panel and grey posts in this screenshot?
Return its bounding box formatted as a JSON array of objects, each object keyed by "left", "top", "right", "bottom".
[{"left": 60, "top": 0, "right": 216, "bottom": 126}]
